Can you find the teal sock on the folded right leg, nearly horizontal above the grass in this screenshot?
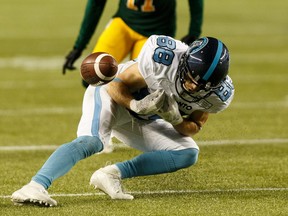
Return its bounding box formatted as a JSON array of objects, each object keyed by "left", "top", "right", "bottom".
[{"left": 116, "top": 148, "right": 198, "bottom": 178}]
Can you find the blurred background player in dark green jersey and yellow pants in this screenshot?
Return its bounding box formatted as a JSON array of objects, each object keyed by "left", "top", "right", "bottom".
[{"left": 63, "top": 0, "right": 203, "bottom": 87}]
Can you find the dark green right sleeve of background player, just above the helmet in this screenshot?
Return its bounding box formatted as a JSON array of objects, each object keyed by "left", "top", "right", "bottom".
[{"left": 189, "top": 0, "right": 204, "bottom": 37}]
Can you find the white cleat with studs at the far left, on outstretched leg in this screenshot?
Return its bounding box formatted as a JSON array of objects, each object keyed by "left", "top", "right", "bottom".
[{"left": 11, "top": 181, "right": 57, "bottom": 207}]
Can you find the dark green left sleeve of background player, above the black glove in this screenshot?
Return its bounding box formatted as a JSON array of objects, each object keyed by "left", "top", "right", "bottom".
[{"left": 74, "top": 0, "right": 106, "bottom": 50}]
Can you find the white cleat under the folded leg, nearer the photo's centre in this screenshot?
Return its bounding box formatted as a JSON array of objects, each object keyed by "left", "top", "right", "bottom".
[{"left": 90, "top": 165, "right": 134, "bottom": 200}]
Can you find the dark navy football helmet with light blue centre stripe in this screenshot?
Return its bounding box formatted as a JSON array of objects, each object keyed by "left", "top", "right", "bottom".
[{"left": 177, "top": 37, "right": 230, "bottom": 94}]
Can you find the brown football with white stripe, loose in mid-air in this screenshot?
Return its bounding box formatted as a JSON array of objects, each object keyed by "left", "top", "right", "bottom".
[{"left": 80, "top": 52, "right": 118, "bottom": 86}]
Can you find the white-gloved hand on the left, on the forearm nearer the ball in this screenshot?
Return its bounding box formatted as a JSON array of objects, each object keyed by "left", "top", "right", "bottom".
[{"left": 130, "top": 90, "right": 165, "bottom": 115}]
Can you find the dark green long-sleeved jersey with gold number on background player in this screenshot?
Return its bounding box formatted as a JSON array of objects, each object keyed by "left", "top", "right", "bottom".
[{"left": 74, "top": 0, "right": 203, "bottom": 49}]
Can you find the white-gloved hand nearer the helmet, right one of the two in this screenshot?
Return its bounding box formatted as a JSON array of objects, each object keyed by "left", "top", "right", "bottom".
[{"left": 156, "top": 95, "right": 183, "bottom": 125}]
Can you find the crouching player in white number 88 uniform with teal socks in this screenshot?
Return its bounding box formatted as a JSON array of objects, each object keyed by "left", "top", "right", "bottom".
[{"left": 12, "top": 35, "right": 234, "bottom": 206}]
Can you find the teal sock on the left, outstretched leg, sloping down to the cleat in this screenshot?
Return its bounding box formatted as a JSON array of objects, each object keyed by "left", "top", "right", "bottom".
[{"left": 32, "top": 136, "right": 103, "bottom": 189}]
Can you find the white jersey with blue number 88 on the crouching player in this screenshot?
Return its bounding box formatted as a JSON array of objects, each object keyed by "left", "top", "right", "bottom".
[{"left": 134, "top": 35, "right": 234, "bottom": 119}]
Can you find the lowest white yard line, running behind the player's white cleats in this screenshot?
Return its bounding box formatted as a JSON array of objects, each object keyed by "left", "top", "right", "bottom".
[{"left": 0, "top": 188, "right": 288, "bottom": 199}]
